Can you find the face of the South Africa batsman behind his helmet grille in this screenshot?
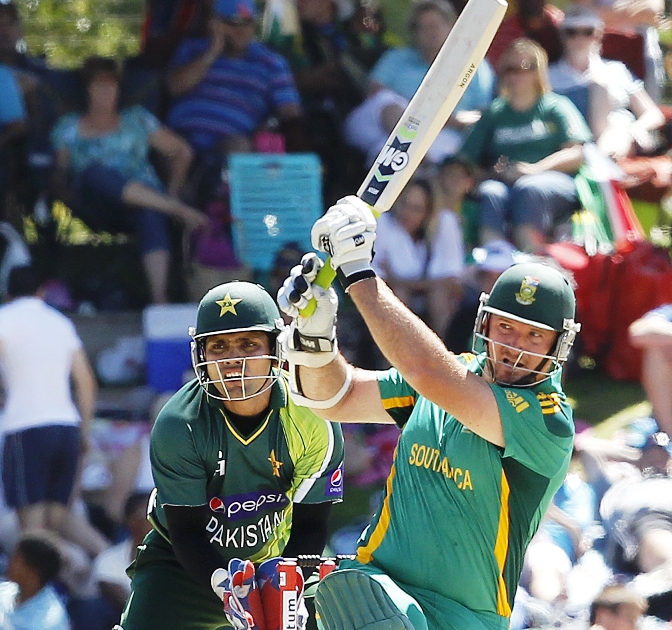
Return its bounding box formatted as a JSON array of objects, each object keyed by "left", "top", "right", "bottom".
[{"left": 488, "top": 314, "right": 557, "bottom": 385}]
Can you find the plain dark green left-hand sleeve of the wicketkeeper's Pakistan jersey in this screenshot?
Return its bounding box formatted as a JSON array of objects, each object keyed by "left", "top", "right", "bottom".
[{"left": 149, "top": 405, "right": 207, "bottom": 507}]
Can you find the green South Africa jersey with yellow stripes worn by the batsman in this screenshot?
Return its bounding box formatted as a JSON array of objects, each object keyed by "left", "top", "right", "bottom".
[{"left": 357, "top": 354, "right": 574, "bottom": 629}]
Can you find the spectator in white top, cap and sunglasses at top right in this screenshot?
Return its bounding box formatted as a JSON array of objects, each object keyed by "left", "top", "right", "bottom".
[{"left": 549, "top": 5, "right": 665, "bottom": 160}]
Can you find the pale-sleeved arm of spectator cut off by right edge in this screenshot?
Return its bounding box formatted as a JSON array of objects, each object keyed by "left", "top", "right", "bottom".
[{"left": 628, "top": 304, "right": 672, "bottom": 442}]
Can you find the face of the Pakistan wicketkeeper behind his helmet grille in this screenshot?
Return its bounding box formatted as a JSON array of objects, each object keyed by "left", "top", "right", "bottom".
[{"left": 204, "top": 330, "right": 273, "bottom": 400}]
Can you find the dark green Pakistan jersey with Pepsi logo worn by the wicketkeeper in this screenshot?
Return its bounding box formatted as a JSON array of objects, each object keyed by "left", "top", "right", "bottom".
[{"left": 150, "top": 375, "right": 343, "bottom": 566}]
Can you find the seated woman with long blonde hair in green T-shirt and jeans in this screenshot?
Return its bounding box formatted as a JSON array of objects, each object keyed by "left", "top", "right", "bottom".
[{"left": 462, "top": 38, "right": 591, "bottom": 253}]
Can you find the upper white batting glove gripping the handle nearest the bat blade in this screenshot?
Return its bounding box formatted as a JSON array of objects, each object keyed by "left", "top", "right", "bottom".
[{"left": 310, "top": 195, "right": 376, "bottom": 292}]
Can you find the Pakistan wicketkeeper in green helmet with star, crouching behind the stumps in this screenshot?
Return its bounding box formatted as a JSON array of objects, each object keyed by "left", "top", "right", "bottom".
[{"left": 115, "top": 282, "right": 343, "bottom": 630}]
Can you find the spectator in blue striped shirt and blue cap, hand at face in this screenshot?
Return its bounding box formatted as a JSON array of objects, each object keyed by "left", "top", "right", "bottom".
[{"left": 167, "top": 0, "right": 301, "bottom": 167}]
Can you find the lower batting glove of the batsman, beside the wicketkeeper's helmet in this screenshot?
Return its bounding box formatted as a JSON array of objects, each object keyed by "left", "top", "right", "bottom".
[{"left": 278, "top": 253, "right": 338, "bottom": 367}]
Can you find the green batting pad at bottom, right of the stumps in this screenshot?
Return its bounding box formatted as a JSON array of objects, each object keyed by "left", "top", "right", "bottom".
[{"left": 315, "top": 569, "right": 415, "bottom": 630}]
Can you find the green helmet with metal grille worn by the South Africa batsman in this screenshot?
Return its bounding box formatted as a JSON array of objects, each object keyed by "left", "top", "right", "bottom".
[{"left": 474, "top": 262, "right": 581, "bottom": 386}]
